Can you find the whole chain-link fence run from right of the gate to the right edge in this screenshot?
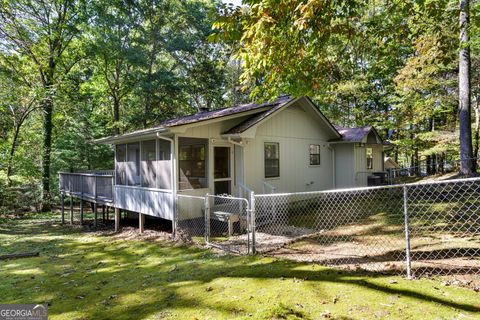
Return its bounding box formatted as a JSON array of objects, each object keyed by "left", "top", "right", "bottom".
[{"left": 254, "top": 178, "right": 480, "bottom": 277}]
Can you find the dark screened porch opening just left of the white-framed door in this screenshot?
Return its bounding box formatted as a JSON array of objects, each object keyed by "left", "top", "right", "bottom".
[{"left": 178, "top": 138, "right": 208, "bottom": 189}]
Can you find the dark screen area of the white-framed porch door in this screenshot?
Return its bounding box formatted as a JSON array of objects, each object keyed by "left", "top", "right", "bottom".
[{"left": 213, "top": 146, "right": 232, "bottom": 194}]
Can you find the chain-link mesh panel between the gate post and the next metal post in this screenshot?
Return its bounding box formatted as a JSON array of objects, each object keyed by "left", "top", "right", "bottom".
[{"left": 255, "top": 187, "right": 405, "bottom": 271}]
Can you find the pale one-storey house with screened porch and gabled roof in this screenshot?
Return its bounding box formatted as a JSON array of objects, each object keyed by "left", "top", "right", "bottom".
[{"left": 60, "top": 96, "right": 383, "bottom": 230}]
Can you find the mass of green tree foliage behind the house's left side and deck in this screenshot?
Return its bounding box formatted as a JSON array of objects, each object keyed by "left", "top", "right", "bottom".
[{"left": 0, "top": 0, "right": 230, "bottom": 205}]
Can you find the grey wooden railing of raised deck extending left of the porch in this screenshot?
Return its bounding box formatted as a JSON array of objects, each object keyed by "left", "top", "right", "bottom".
[{"left": 59, "top": 170, "right": 114, "bottom": 202}]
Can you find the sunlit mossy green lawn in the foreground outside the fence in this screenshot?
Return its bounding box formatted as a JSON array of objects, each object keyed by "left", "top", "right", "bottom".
[{"left": 0, "top": 215, "right": 480, "bottom": 319}]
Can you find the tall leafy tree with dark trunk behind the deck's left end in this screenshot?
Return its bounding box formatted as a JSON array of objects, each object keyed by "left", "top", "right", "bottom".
[{"left": 0, "top": 0, "right": 79, "bottom": 210}]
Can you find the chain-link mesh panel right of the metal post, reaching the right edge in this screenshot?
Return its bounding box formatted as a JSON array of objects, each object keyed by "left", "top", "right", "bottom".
[{"left": 406, "top": 179, "right": 480, "bottom": 277}]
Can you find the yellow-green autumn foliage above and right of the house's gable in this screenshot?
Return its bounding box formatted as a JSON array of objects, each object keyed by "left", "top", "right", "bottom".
[{"left": 214, "top": 0, "right": 480, "bottom": 166}]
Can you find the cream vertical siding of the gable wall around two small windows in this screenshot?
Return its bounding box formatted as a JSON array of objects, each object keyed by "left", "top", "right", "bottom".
[{"left": 243, "top": 105, "right": 333, "bottom": 193}]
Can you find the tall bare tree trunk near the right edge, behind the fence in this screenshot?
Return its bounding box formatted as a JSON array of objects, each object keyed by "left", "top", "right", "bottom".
[{"left": 458, "top": 0, "right": 474, "bottom": 176}]
